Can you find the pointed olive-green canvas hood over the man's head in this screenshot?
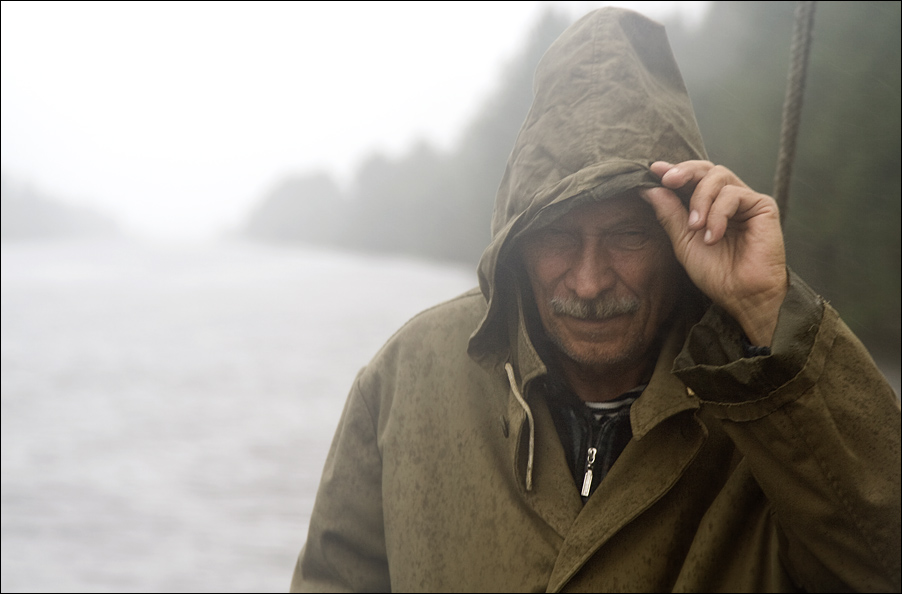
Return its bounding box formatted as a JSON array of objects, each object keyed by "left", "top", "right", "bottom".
[{"left": 468, "top": 8, "right": 707, "bottom": 365}]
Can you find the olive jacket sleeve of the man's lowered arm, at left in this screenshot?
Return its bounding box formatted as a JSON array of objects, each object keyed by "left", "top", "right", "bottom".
[{"left": 291, "top": 372, "right": 391, "bottom": 592}]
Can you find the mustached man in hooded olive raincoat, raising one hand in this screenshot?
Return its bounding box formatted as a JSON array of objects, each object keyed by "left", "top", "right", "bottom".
[{"left": 292, "top": 9, "right": 900, "bottom": 592}]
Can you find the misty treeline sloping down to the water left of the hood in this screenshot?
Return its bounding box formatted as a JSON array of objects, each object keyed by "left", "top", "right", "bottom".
[{"left": 245, "top": 11, "right": 569, "bottom": 265}]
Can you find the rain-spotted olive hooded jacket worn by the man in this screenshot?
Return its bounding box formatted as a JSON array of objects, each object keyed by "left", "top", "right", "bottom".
[{"left": 292, "top": 8, "right": 900, "bottom": 592}]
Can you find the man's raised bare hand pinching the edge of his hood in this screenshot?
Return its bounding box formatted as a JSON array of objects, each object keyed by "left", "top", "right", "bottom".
[{"left": 642, "top": 161, "right": 788, "bottom": 346}]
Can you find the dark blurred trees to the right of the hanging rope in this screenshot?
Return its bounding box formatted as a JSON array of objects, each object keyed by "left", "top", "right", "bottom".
[{"left": 787, "top": 2, "right": 902, "bottom": 354}]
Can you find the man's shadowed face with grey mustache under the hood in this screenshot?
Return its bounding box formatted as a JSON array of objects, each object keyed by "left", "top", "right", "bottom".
[{"left": 522, "top": 194, "right": 682, "bottom": 372}]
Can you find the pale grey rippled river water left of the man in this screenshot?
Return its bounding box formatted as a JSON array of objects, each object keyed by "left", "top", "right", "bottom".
[{"left": 0, "top": 242, "right": 476, "bottom": 592}]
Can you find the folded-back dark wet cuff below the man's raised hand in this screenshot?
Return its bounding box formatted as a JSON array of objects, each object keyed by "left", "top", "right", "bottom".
[{"left": 673, "top": 270, "right": 824, "bottom": 404}]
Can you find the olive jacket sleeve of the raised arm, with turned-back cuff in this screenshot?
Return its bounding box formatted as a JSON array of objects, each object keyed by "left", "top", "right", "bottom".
[{"left": 674, "top": 273, "right": 902, "bottom": 592}]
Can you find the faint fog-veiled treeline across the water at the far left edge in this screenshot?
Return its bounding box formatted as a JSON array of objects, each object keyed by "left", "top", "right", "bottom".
[{"left": 0, "top": 176, "right": 120, "bottom": 242}]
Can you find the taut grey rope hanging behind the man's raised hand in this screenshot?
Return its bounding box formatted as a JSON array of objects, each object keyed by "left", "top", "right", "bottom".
[{"left": 774, "top": 2, "right": 817, "bottom": 223}]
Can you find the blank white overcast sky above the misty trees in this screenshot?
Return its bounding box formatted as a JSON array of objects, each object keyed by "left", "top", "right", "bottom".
[{"left": 0, "top": 1, "right": 709, "bottom": 241}]
